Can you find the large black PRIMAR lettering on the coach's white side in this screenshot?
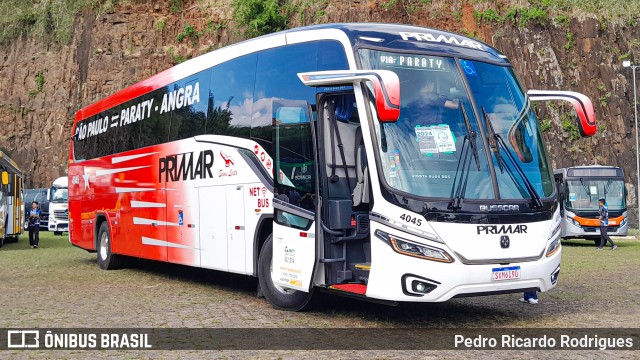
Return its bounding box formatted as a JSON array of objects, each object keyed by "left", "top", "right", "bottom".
[{"left": 158, "top": 150, "right": 213, "bottom": 182}]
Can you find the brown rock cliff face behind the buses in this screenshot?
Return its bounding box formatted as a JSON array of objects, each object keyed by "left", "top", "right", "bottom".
[{"left": 0, "top": 0, "right": 640, "bottom": 219}]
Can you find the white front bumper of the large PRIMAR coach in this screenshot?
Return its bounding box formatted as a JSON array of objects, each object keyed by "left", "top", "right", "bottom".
[{"left": 366, "top": 223, "right": 561, "bottom": 302}]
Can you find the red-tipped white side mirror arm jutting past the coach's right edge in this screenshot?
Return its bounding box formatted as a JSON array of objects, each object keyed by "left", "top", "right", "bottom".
[{"left": 527, "top": 90, "right": 596, "bottom": 136}]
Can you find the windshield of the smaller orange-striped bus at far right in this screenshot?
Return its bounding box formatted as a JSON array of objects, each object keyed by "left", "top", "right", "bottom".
[{"left": 565, "top": 179, "right": 627, "bottom": 211}]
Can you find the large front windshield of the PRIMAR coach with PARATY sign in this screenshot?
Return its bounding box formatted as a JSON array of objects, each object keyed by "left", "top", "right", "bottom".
[{"left": 359, "top": 49, "right": 554, "bottom": 199}]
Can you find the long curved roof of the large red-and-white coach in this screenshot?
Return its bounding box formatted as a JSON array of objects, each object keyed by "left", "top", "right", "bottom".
[{"left": 75, "top": 23, "right": 509, "bottom": 122}]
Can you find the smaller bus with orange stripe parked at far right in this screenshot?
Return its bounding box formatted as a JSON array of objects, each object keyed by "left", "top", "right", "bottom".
[{"left": 554, "top": 165, "right": 628, "bottom": 244}]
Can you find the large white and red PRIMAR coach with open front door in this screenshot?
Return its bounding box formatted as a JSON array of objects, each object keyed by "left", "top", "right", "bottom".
[{"left": 69, "top": 24, "right": 596, "bottom": 310}]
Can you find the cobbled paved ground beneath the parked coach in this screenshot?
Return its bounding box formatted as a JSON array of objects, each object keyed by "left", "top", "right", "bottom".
[{"left": 0, "top": 233, "right": 640, "bottom": 359}]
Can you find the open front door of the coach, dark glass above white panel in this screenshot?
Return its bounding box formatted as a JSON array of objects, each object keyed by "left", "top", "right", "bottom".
[{"left": 271, "top": 100, "right": 318, "bottom": 293}]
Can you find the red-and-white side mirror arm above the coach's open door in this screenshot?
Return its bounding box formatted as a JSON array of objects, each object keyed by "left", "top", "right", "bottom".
[{"left": 298, "top": 70, "right": 400, "bottom": 122}]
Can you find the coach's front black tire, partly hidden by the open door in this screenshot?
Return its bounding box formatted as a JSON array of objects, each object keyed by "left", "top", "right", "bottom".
[{"left": 258, "top": 235, "right": 314, "bottom": 311}]
